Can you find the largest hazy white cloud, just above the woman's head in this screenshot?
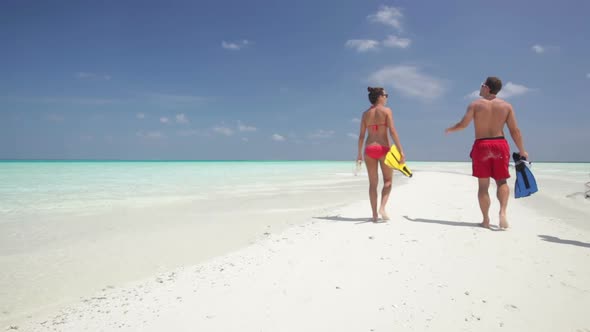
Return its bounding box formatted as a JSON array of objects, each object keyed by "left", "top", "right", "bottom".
[{"left": 369, "top": 65, "right": 446, "bottom": 100}]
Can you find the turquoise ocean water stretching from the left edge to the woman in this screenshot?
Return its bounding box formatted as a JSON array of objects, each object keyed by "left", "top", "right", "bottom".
[{"left": 0, "top": 161, "right": 368, "bottom": 222}]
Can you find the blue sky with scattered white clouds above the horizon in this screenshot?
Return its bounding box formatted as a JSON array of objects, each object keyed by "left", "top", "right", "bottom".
[{"left": 0, "top": 0, "right": 590, "bottom": 161}]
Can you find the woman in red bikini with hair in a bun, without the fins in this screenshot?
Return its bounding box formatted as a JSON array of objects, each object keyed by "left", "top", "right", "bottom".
[{"left": 356, "top": 87, "right": 406, "bottom": 222}]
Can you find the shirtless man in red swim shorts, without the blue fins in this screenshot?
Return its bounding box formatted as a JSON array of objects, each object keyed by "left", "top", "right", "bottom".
[{"left": 445, "top": 77, "right": 528, "bottom": 229}]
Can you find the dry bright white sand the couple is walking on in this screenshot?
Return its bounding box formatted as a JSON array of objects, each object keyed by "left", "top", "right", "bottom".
[{"left": 8, "top": 172, "right": 590, "bottom": 331}]
